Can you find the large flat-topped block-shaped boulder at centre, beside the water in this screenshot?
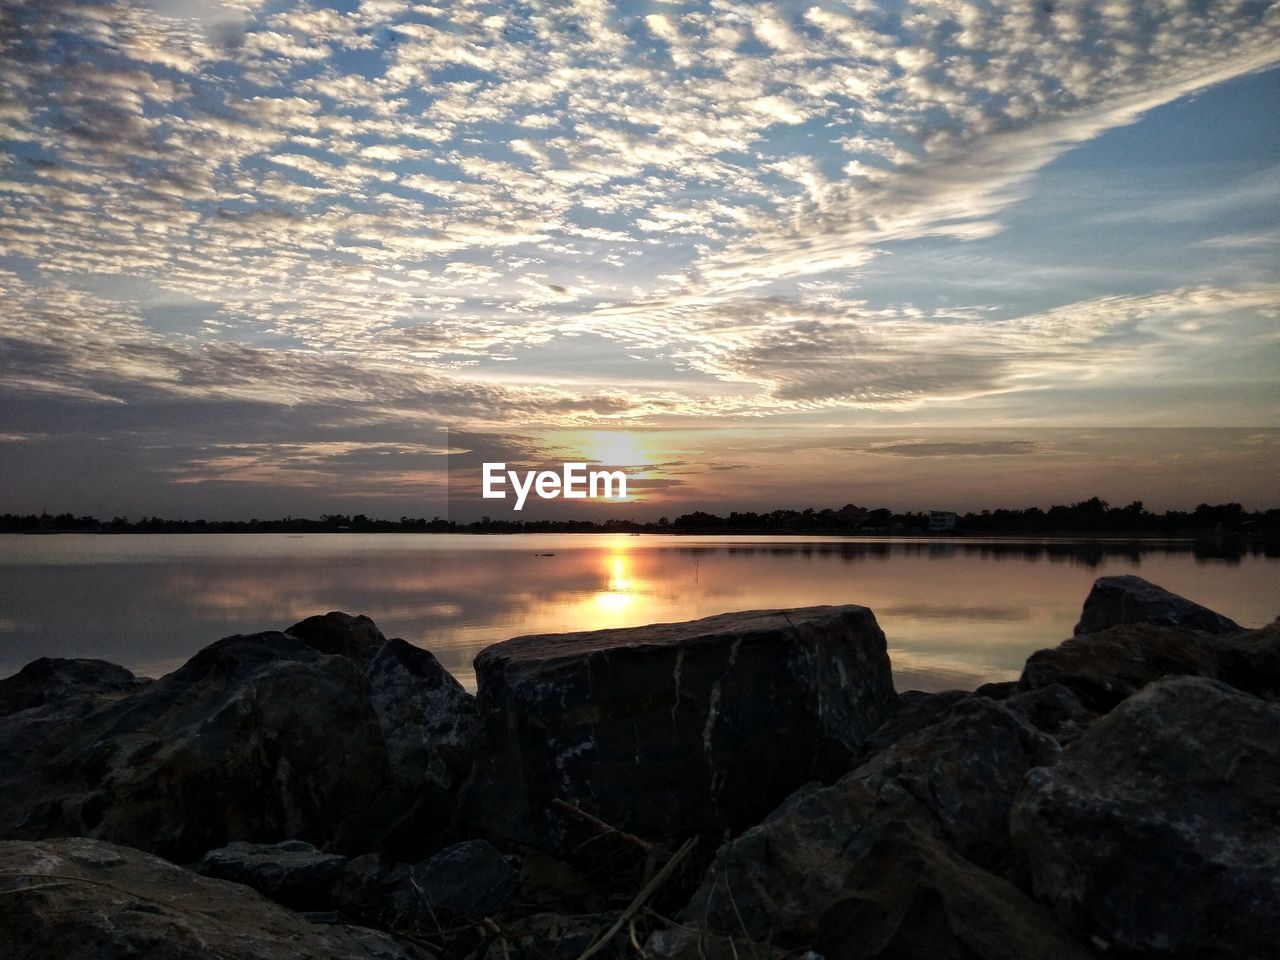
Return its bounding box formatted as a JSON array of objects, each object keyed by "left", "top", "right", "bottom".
[{"left": 461, "top": 607, "right": 896, "bottom": 849}]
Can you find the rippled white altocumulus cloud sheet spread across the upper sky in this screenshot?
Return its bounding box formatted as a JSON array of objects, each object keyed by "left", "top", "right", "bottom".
[{"left": 0, "top": 0, "right": 1280, "bottom": 512}]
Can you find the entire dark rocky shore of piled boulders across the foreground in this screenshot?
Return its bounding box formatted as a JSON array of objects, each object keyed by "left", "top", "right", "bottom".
[{"left": 0, "top": 576, "right": 1280, "bottom": 960}]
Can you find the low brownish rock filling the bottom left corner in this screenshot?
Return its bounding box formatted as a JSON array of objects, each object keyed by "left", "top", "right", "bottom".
[{"left": 0, "top": 840, "right": 430, "bottom": 960}]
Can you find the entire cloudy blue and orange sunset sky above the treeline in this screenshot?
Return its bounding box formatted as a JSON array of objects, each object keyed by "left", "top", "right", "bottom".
[{"left": 0, "top": 0, "right": 1280, "bottom": 527}]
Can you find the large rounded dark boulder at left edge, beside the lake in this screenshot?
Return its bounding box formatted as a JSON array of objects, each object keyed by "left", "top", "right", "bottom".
[{"left": 0, "top": 634, "right": 394, "bottom": 863}]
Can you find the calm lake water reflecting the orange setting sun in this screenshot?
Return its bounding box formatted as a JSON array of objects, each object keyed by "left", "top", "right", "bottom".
[{"left": 0, "top": 534, "right": 1280, "bottom": 690}]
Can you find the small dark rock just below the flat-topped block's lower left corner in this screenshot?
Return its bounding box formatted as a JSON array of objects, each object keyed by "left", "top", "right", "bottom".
[{"left": 334, "top": 840, "right": 520, "bottom": 932}]
